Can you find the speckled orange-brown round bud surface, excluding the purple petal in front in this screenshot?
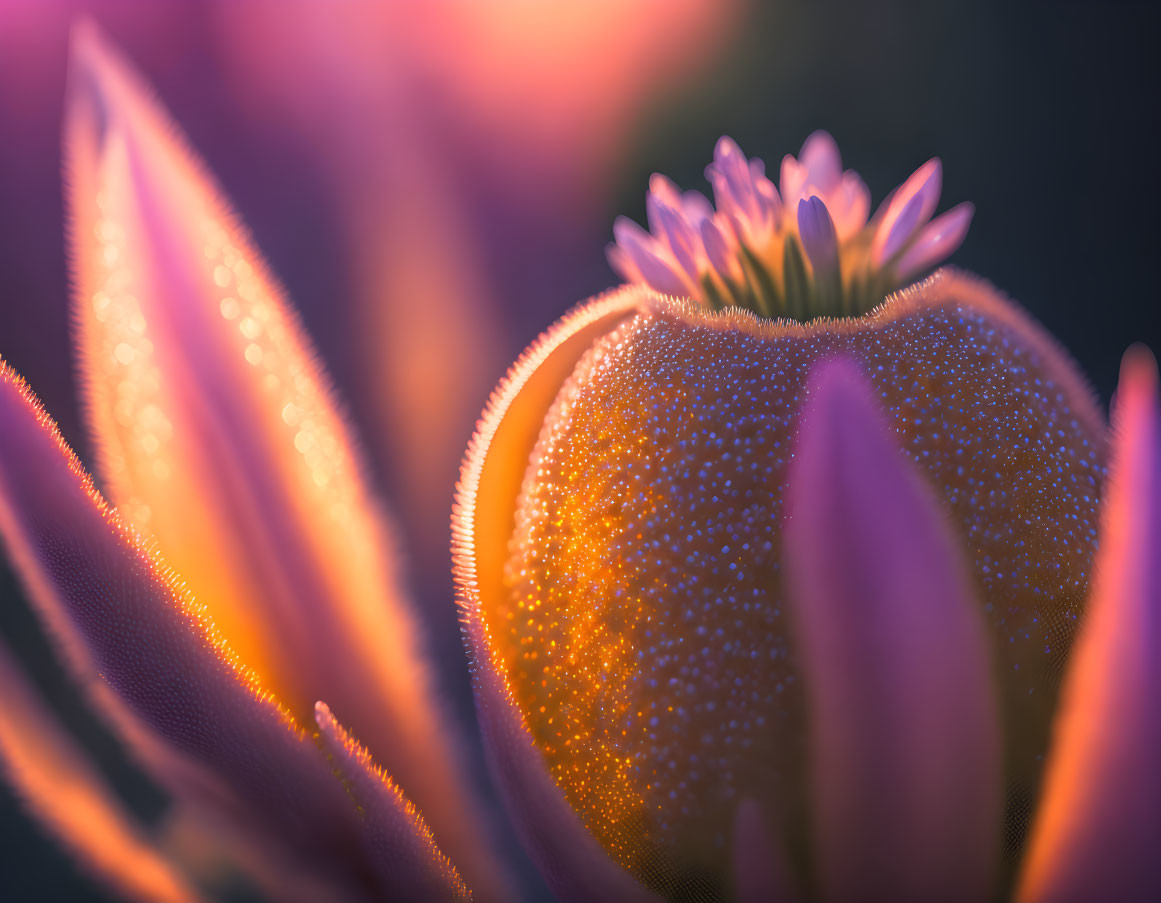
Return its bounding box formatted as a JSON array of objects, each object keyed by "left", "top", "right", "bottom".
[{"left": 482, "top": 274, "right": 1105, "bottom": 893}]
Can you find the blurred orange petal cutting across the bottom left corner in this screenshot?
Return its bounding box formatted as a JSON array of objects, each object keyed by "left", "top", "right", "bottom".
[{"left": 0, "top": 645, "right": 201, "bottom": 903}]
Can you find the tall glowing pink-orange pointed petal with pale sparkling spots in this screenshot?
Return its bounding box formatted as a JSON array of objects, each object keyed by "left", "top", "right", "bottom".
[{"left": 66, "top": 28, "right": 499, "bottom": 888}]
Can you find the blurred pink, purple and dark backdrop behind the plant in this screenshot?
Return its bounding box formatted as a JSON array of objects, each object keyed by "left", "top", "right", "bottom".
[{"left": 0, "top": 0, "right": 1161, "bottom": 901}]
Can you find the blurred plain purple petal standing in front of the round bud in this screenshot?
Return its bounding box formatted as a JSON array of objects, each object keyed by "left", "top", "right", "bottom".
[{"left": 784, "top": 360, "right": 1001, "bottom": 901}]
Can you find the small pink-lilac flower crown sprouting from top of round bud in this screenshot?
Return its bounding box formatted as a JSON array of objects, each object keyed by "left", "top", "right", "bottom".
[{"left": 608, "top": 131, "right": 974, "bottom": 320}]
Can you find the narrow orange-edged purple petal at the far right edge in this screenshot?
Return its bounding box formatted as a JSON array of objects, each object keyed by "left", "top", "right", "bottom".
[{"left": 1019, "top": 347, "right": 1161, "bottom": 903}]
